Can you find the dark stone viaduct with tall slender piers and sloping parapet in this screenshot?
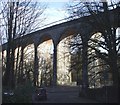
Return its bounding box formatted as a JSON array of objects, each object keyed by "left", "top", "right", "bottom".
[{"left": 2, "top": 7, "right": 120, "bottom": 86}]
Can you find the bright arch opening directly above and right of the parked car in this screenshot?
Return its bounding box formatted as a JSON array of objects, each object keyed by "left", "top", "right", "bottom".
[{"left": 37, "top": 39, "right": 54, "bottom": 86}]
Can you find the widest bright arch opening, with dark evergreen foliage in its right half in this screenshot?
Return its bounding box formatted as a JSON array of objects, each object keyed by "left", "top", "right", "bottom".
[{"left": 57, "top": 30, "right": 82, "bottom": 86}]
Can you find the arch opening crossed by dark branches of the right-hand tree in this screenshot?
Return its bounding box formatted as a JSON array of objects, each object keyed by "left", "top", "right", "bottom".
[{"left": 88, "top": 32, "right": 113, "bottom": 88}]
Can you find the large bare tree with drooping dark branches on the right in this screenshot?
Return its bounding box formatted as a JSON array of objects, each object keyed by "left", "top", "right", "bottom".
[{"left": 66, "top": 0, "right": 120, "bottom": 101}]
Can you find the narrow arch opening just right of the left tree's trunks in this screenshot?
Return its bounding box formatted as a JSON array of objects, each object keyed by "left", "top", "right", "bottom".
[{"left": 18, "top": 44, "right": 34, "bottom": 82}]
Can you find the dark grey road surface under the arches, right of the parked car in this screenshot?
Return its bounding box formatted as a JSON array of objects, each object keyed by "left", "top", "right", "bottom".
[{"left": 35, "top": 86, "right": 99, "bottom": 103}]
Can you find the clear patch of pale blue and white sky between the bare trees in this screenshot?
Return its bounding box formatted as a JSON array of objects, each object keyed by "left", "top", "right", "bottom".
[{"left": 41, "top": 0, "right": 69, "bottom": 24}]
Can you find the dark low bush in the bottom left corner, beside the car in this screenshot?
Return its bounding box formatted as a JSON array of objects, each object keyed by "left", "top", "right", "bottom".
[{"left": 3, "top": 82, "right": 34, "bottom": 103}]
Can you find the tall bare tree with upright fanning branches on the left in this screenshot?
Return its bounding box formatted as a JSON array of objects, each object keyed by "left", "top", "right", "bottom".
[{"left": 1, "top": 0, "right": 46, "bottom": 88}]
